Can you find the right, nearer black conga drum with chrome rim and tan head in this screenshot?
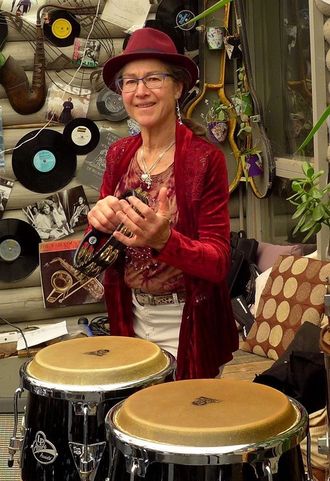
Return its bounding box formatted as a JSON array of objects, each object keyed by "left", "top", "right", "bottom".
[{"left": 105, "top": 379, "right": 308, "bottom": 481}]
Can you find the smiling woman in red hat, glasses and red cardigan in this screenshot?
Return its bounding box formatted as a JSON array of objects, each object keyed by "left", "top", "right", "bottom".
[{"left": 88, "top": 28, "right": 238, "bottom": 379}]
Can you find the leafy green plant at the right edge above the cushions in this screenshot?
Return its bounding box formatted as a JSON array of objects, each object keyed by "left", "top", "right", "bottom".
[{"left": 287, "top": 161, "right": 330, "bottom": 242}]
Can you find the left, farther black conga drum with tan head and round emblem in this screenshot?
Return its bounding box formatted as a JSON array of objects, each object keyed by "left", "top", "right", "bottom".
[{"left": 14, "top": 336, "right": 175, "bottom": 481}]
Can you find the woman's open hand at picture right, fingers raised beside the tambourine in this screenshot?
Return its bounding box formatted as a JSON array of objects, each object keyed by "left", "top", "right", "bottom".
[{"left": 113, "top": 187, "right": 171, "bottom": 250}]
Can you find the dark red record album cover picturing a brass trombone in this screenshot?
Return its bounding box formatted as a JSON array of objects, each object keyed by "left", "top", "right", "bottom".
[{"left": 39, "top": 239, "right": 104, "bottom": 308}]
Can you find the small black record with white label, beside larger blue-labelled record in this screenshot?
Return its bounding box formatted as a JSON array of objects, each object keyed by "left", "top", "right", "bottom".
[{"left": 63, "top": 117, "right": 100, "bottom": 155}]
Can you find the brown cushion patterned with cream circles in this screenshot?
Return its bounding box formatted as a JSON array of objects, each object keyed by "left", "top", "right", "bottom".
[{"left": 241, "top": 255, "right": 330, "bottom": 360}]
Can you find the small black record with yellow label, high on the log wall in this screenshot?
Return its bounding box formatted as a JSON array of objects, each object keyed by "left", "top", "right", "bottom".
[{"left": 43, "top": 10, "right": 80, "bottom": 47}]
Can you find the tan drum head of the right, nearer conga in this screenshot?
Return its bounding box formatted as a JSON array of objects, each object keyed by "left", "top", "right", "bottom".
[{"left": 114, "top": 379, "right": 297, "bottom": 447}]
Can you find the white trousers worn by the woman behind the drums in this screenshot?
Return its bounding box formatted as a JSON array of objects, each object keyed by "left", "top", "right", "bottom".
[{"left": 132, "top": 291, "right": 184, "bottom": 357}]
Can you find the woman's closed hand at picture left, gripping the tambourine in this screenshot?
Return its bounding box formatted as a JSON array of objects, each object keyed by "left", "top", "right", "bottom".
[{"left": 87, "top": 195, "right": 122, "bottom": 234}]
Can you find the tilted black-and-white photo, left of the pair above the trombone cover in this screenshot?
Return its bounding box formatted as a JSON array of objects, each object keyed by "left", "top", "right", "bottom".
[{"left": 22, "top": 194, "right": 73, "bottom": 241}]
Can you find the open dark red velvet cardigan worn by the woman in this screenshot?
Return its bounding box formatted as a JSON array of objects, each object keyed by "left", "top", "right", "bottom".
[{"left": 100, "top": 124, "right": 238, "bottom": 379}]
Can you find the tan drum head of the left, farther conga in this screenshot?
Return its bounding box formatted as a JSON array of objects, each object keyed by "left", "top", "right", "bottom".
[{"left": 27, "top": 336, "right": 169, "bottom": 386}]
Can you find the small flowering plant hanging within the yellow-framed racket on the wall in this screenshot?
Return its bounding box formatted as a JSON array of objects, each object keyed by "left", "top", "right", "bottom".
[{"left": 205, "top": 99, "right": 231, "bottom": 143}]
